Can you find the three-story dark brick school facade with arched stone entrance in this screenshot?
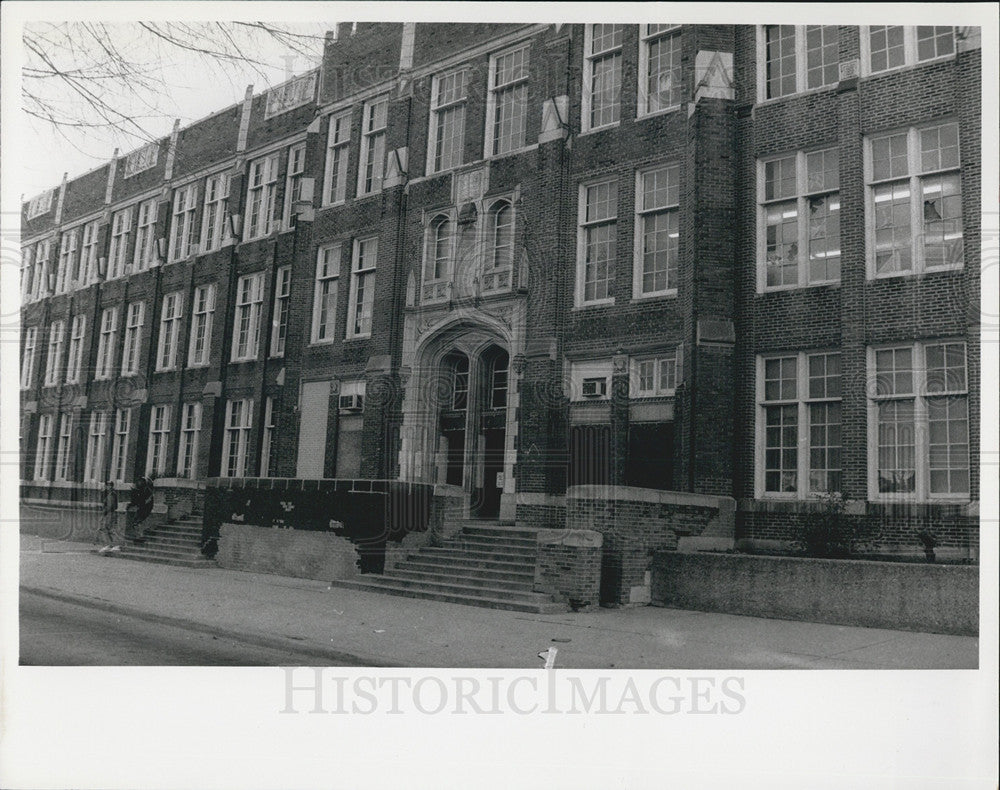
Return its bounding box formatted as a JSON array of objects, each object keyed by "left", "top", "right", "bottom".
[{"left": 20, "top": 23, "right": 981, "bottom": 548}]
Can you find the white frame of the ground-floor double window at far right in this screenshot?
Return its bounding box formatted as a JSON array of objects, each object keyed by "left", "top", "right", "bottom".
[{"left": 867, "top": 337, "right": 972, "bottom": 502}]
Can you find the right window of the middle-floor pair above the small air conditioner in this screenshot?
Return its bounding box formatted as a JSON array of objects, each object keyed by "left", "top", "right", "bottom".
[{"left": 632, "top": 165, "right": 680, "bottom": 297}]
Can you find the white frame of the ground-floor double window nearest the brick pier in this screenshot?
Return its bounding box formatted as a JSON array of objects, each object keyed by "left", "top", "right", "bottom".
[{"left": 754, "top": 349, "right": 846, "bottom": 501}]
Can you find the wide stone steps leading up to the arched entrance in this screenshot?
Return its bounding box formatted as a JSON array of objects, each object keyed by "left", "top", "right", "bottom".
[{"left": 333, "top": 520, "right": 568, "bottom": 614}]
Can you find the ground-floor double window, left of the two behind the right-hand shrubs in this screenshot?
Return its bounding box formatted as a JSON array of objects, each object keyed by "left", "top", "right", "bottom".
[{"left": 757, "top": 353, "right": 842, "bottom": 499}]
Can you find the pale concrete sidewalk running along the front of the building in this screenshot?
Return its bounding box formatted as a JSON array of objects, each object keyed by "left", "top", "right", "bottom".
[{"left": 20, "top": 534, "right": 978, "bottom": 669}]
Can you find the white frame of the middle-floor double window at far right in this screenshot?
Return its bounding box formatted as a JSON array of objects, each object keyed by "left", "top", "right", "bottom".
[{"left": 863, "top": 120, "right": 965, "bottom": 280}]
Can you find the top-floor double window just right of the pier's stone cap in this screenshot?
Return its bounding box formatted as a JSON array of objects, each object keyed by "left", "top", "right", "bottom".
[{"left": 757, "top": 25, "right": 840, "bottom": 101}]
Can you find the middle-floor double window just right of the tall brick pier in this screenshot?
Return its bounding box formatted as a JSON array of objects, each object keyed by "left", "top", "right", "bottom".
[{"left": 758, "top": 148, "right": 840, "bottom": 290}]
